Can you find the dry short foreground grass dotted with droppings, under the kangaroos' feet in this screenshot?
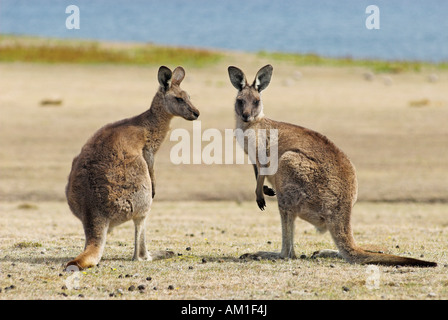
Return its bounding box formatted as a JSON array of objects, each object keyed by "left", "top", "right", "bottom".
[{"left": 0, "top": 202, "right": 448, "bottom": 300}]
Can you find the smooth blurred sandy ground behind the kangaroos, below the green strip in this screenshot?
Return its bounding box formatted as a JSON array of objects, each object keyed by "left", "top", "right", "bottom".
[{"left": 0, "top": 54, "right": 448, "bottom": 201}]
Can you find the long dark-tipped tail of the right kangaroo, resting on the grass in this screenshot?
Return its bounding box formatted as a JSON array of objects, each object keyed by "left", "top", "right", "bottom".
[{"left": 328, "top": 215, "right": 437, "bottom": 267}]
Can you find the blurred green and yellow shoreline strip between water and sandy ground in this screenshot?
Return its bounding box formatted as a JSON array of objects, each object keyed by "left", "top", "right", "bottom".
[{"left": 0, "top": 34, "right": 448, "bottom": 73}]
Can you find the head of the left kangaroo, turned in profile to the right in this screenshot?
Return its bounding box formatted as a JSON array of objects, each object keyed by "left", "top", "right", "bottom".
[{"left": 158, "top": 66, "right": 199, "bottom": 120}]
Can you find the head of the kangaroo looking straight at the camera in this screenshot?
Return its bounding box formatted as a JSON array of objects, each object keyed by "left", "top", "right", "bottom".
[{"left": 228, "top": 64, "right": 273, "bottom": 122}]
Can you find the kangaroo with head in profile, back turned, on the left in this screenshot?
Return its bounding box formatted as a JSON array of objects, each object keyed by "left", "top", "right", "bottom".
[{"left": 66, "top": 66, "right": 199, "bottom": 269}]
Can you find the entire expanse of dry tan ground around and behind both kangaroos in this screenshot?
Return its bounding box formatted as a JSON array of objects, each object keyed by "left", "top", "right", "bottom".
[{"left": 0, "top": 37, "right": 448, "bottom": 299}]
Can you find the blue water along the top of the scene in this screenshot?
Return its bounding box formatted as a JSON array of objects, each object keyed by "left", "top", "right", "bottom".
[{"left": 0, "top": 0, "right": 448, "bottom": 62}]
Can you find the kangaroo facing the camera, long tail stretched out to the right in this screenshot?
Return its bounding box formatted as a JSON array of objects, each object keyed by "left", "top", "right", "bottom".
[{"left": 228, "top": 65, "right": 437, "bottom": 267}]
